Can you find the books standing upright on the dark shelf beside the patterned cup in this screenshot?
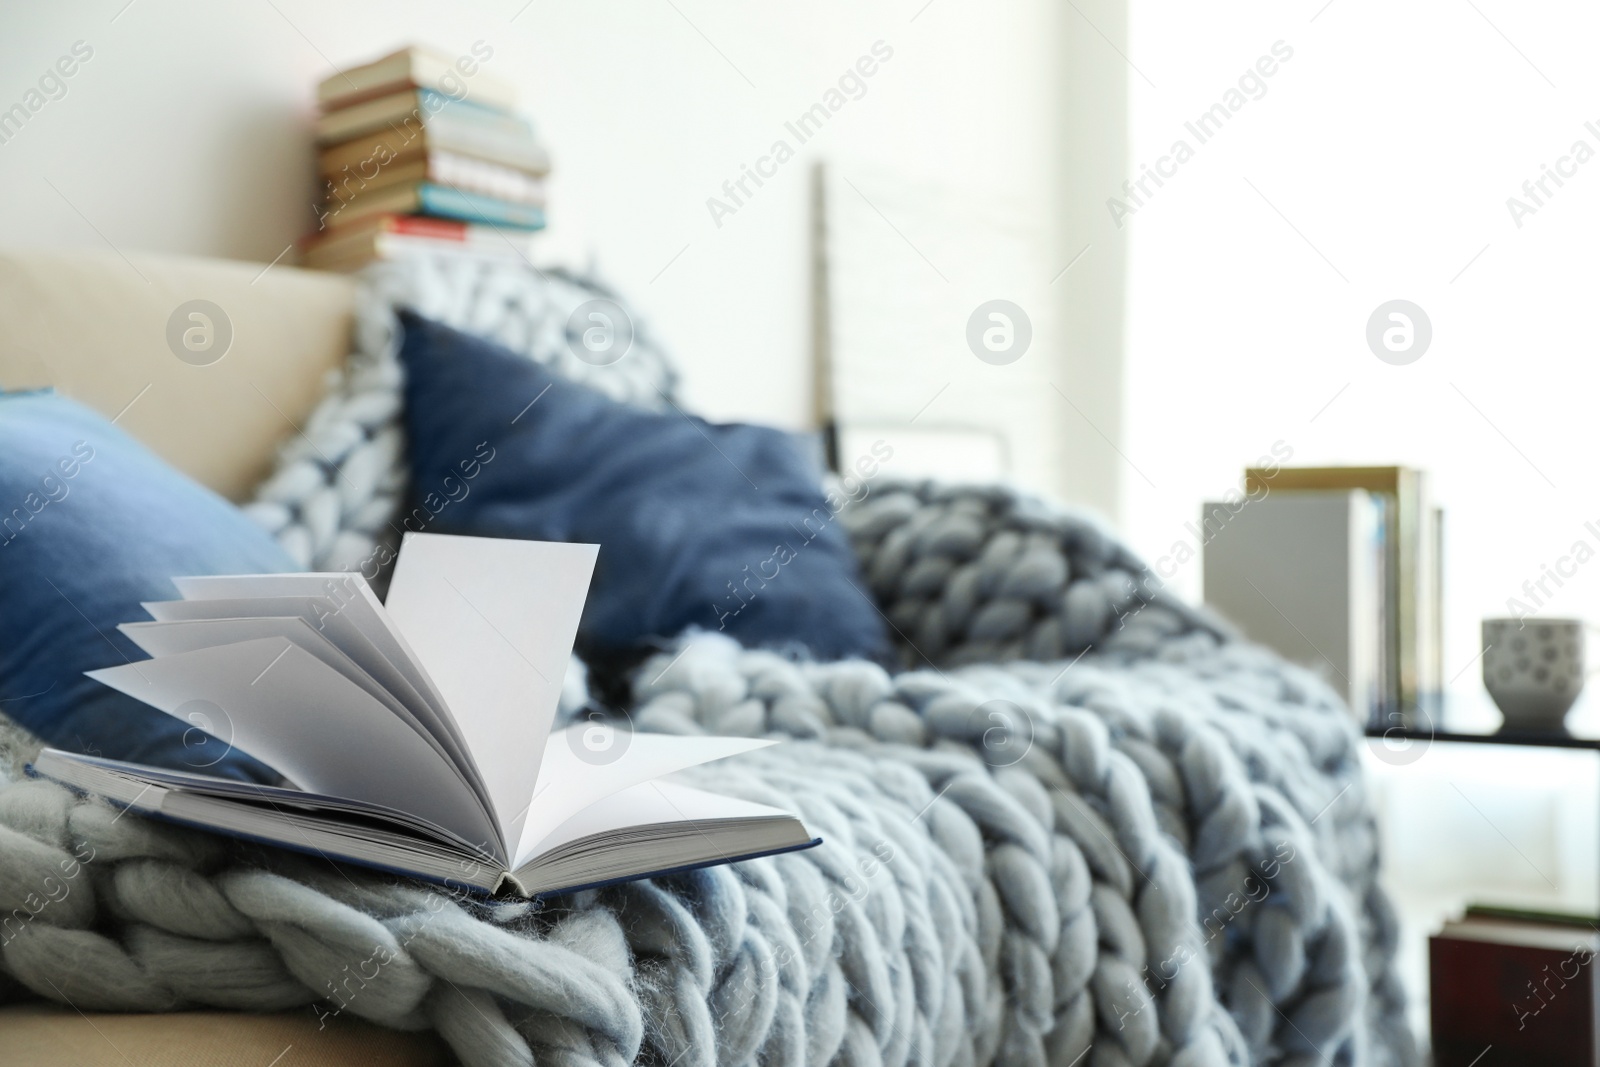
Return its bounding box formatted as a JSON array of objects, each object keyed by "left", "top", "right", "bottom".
[{"left": 1200, "top": 467, "right": 1443, "bottom": 726}]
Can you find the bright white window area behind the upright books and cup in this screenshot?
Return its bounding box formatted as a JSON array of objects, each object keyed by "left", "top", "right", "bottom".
[{"left": 1102, "top": 0, "right": 1600, "bottom": 1024}]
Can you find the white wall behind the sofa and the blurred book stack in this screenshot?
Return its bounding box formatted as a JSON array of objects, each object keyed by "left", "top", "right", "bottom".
[{"left": 0, "top": 0, "right": 1122, "bottom": 510}]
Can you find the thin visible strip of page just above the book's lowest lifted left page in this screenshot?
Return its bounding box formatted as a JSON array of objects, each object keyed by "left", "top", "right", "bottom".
[{"left": 117, "top": 616, "right": 488, "bottom": 806}]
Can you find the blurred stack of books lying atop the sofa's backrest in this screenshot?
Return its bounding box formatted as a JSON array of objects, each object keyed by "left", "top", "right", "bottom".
[{"left": 301, "top": 48, "right": 550, "bottom": 270}]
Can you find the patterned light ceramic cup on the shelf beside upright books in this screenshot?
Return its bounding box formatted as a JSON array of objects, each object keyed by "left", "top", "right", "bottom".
[{"left": 1483, "top": 617, "right": 1584, "bottom": 731}]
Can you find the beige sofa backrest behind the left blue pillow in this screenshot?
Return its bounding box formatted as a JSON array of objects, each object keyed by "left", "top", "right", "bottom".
[{"left": 0, "top": 250, "right": 354, "bottom": 501}]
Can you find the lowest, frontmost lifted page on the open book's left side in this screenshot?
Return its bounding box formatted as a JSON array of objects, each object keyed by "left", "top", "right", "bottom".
[{"left": 86, "top": 637, "right": 504, "bottom": 853}]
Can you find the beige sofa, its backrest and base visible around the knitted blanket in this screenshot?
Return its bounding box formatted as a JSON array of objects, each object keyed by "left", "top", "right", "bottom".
[{"left": 0, "top": 250, "right": 451, "bottom": 1067}]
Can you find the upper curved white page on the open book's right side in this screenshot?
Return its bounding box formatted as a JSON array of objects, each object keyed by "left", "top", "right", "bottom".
[{"left": 512, "top": 723, "right": 778, "bottom": 867}]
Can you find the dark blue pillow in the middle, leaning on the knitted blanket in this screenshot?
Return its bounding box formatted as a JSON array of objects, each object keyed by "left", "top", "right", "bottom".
[{"left": 390, "top": 314, "right": 888, "bottom": 659}]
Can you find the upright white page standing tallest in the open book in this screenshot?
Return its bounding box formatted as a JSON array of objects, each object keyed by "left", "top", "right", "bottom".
[{"left": 386, "top": 533, "right": 598, "bottom": 846}]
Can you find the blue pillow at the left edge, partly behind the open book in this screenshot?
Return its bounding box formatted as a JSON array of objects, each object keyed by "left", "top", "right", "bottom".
[{"left": 0, "top": 392, "right": 296, "bottom": 782}]
